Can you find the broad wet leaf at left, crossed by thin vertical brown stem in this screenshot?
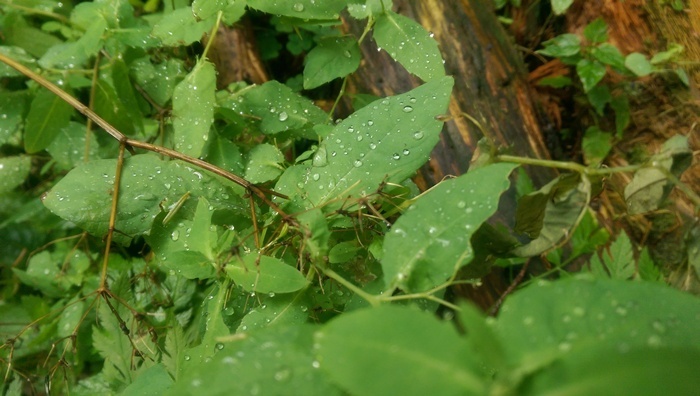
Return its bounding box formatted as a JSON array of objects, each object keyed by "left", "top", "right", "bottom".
[{"left": 44, "top": 154, "right": 248, "bottom": 242}]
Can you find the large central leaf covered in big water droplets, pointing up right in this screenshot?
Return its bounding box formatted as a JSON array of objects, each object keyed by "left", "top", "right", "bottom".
[{"left": 275, "top": 77, "right": 453, "bottom": 211}]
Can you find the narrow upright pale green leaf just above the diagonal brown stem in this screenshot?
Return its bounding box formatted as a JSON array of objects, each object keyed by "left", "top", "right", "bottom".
[{"left": 173, "top": 60, "right": 216, "bottom": 157}]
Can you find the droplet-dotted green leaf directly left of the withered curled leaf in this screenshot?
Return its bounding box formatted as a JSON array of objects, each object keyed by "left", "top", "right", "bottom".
[{"left": 382, "top": 163, "right": 515, "bottom": 292}]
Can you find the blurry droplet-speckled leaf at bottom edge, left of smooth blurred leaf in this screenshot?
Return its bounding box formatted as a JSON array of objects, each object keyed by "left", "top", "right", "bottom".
[{"left": 166, "top": 325, "right": 342, "bottom": 396}]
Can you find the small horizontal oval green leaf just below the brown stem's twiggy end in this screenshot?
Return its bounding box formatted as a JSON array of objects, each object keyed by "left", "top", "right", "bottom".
[{"left": 226, "top": 254, "right": 308, "bottom": 293}]
